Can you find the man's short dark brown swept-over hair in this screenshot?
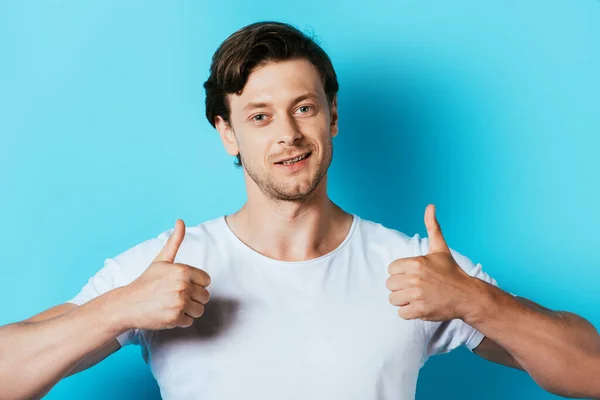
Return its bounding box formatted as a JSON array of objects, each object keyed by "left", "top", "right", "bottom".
[{"left": 204, "top": 21, "right": 339, "bottom": 166}]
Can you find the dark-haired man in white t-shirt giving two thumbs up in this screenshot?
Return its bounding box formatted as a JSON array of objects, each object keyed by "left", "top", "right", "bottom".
[{"left": 0, "top": 22, "right": 600, "bottom": 400}]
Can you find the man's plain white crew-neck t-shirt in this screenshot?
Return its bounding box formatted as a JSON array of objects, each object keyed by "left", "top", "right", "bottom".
[{"left": 70, "top": 215, "right": 497, "bottom": 400}]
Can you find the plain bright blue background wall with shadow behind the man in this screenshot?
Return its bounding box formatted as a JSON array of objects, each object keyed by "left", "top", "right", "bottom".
[{"left": 0, "top": 0, "right": 600, "bottom": 400}]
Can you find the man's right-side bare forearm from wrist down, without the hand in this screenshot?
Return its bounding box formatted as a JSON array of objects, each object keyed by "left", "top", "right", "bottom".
[{"left": 464, "top": 280, "right": 600, "bottom": 398}]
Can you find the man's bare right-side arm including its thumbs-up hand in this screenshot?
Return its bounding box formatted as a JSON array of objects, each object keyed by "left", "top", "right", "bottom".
[{"left": 386, "top": 205, "right": 600, "bottom": 399}]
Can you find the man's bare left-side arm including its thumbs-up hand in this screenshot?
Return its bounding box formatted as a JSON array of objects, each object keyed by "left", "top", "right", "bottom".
[{"left": 0, "top": 220, "right": 210, "bottom": 400}]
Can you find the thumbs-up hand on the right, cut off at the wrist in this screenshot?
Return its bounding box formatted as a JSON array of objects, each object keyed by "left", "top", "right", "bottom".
[{"left": 386, "top": 204, "right": 474, "bottom": 321}]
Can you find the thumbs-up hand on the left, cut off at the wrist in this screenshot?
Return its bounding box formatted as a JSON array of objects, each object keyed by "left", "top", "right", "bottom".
[{"left": 120, "top": 219, "right": 210, "bottom": 330}]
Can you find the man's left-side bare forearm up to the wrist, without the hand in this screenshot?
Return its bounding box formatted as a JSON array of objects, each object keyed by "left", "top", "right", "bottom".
[{"left": 0, "top": 289, "right": 127, "bottom": 399}]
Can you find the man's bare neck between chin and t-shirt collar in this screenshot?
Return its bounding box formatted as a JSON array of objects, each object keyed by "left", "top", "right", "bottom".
[{"left": 226, "top": 176, "right": 352, "bottom": 261}]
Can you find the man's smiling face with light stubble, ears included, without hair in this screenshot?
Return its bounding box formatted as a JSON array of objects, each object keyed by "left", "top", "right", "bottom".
[{"left": 217, "top": 59, "right": 337, "bottom": 200}]
